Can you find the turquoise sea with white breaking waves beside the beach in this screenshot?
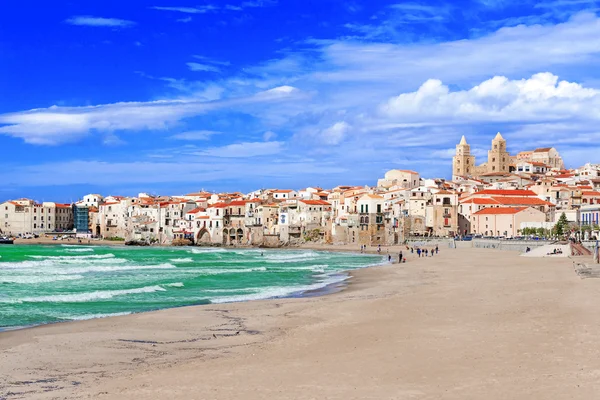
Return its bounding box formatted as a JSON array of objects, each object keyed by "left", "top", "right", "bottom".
[{"left": 0, "top": 245, "right": 383, "bottom": 329}]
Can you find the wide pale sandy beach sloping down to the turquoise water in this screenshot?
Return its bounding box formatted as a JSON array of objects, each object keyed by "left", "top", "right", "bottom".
[{"left": 0, "top": 249, "right": 600, "bottom": 400}]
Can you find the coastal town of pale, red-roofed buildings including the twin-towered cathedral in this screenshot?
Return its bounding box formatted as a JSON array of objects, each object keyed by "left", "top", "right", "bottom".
[{"left": 0, "top": 133, "right": 600, "bottom": 247}]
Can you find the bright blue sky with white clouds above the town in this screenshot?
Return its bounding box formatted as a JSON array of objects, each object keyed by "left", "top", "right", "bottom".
[{"left": 0, "top": 0, "right": 600, "bottom": 201}]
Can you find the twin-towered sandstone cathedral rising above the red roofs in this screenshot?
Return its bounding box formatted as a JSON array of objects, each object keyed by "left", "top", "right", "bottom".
[{"left": 452, "top": 132, "right": 564, "bottom": 180}]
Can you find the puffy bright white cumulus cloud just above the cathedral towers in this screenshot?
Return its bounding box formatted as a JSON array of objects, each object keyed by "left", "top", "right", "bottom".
[{"left": 380, "top": 72, "right": 600, "bottom": 122}]
